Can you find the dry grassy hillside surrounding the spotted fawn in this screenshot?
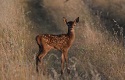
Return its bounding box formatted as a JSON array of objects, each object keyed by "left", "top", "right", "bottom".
[{"left": 0, "top": 0, "right": 125, "bottom": 80}]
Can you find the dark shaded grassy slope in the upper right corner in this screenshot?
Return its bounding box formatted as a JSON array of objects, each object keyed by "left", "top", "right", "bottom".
[{"left": 83, "top": 0, "right": 125, "bottom": 36}]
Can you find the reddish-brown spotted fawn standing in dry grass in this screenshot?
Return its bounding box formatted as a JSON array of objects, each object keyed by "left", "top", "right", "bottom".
[{"left": 36, "top": 17, "right": 79, "bottom": 74}]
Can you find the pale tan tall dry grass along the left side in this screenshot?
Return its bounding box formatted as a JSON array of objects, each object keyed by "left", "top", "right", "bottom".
[{"left": 0, "top": 0, "right": 47, "bottom": 80}]
